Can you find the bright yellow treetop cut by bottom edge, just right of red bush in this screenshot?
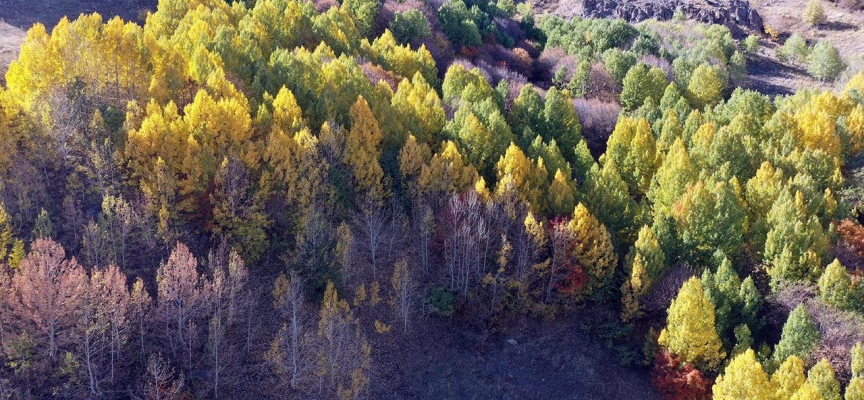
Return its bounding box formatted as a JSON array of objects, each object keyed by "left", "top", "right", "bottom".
[{"left": 711, "top": 349, "right": 774, "bottom": 400}]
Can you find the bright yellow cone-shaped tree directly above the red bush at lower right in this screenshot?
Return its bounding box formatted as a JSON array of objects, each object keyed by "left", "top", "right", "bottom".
[{"left": 659, "top": 277, "right": 726, "bottom": 368}]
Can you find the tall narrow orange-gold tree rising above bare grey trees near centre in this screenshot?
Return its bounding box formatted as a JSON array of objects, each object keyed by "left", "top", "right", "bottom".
[{"left": 345, "top": 96, "right": 384, "bottom": 201}]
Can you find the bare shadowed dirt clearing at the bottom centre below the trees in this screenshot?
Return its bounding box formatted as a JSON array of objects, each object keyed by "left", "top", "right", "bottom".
[{"left": 372, "top": 315, "right": 660, "bottom": 400}]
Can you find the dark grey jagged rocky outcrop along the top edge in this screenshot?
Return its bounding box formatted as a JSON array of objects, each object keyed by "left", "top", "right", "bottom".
[{"left": 581, "top": 0, "right": 763, "bottom": 32}]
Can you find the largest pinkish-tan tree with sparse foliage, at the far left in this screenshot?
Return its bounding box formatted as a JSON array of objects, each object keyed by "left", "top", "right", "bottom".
[{"left": 12, "top": 238, "right": 87, "bottom": 361}]
